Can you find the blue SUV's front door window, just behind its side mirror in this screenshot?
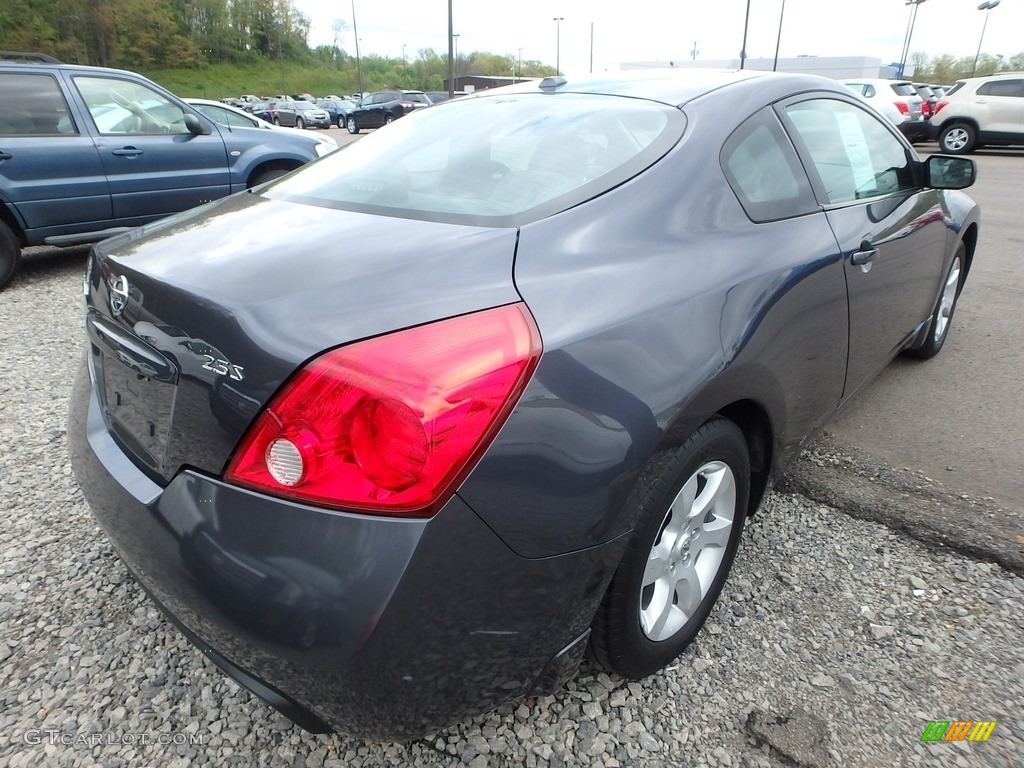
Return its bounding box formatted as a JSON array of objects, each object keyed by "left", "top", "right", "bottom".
[{"left": 75, "top": 76, "right": 188, "bottom": 135}]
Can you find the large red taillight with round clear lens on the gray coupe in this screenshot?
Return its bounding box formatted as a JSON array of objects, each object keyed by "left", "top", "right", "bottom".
[{"left": 225, "top": 304, "right": 541, "bottom": 517}]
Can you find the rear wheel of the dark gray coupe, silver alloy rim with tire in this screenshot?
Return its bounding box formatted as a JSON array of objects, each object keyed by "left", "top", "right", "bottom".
[{"left": 591, "top": 418, "right": 751, "bottom": 679}]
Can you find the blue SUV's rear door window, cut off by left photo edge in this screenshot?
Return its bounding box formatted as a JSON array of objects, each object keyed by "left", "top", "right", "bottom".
[{"left": 0, "top": 72, "right": 78, "bottom": 136}]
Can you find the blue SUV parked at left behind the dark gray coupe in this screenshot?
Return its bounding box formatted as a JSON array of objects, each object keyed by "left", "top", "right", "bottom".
[{"left": 0, "top": 51, "right": 337, "bottom": 288}]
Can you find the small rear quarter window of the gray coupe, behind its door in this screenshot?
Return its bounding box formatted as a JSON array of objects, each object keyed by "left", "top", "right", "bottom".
[{"left": 721, "top": 108, "right": 818, "bottom": 222}]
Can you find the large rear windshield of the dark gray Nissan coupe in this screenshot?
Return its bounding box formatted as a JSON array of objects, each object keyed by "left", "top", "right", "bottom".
[{"left": 265, "top": 93, "right": 685, "bottom": 226}]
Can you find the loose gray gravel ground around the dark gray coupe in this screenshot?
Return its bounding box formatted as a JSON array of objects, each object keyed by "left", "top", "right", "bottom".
[{"left": 0, "top": 252, "right": 1024, "bottom": 768}]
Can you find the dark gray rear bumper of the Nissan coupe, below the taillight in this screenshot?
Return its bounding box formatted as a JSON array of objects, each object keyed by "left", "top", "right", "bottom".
[{"left": 68, "top": 354, "right": 624, "bottom": 738}]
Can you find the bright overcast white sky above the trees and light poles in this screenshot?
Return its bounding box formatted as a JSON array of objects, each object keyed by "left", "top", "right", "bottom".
[{"left": 294, "top": 0, "right": 1024, "bottom": 75}]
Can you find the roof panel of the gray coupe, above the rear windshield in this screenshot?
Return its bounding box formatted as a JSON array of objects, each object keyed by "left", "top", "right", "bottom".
[{"left": 483, "top": 68, "right": 847, "bottom": 106}]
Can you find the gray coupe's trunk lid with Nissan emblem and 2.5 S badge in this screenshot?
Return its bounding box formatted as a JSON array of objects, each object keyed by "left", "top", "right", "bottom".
[{"left": 86, "top": 194, "right": 519, "bottom": 481}]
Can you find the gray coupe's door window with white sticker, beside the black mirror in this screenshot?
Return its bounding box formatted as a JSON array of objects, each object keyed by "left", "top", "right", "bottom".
[{"left": 784, "top": 98, "right": 918, "bottom": 204}]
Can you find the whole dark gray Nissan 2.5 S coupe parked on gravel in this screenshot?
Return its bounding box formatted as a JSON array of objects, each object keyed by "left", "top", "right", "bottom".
[{"left": 69, "top": 71, "right": 979, "bottom": 738}]
